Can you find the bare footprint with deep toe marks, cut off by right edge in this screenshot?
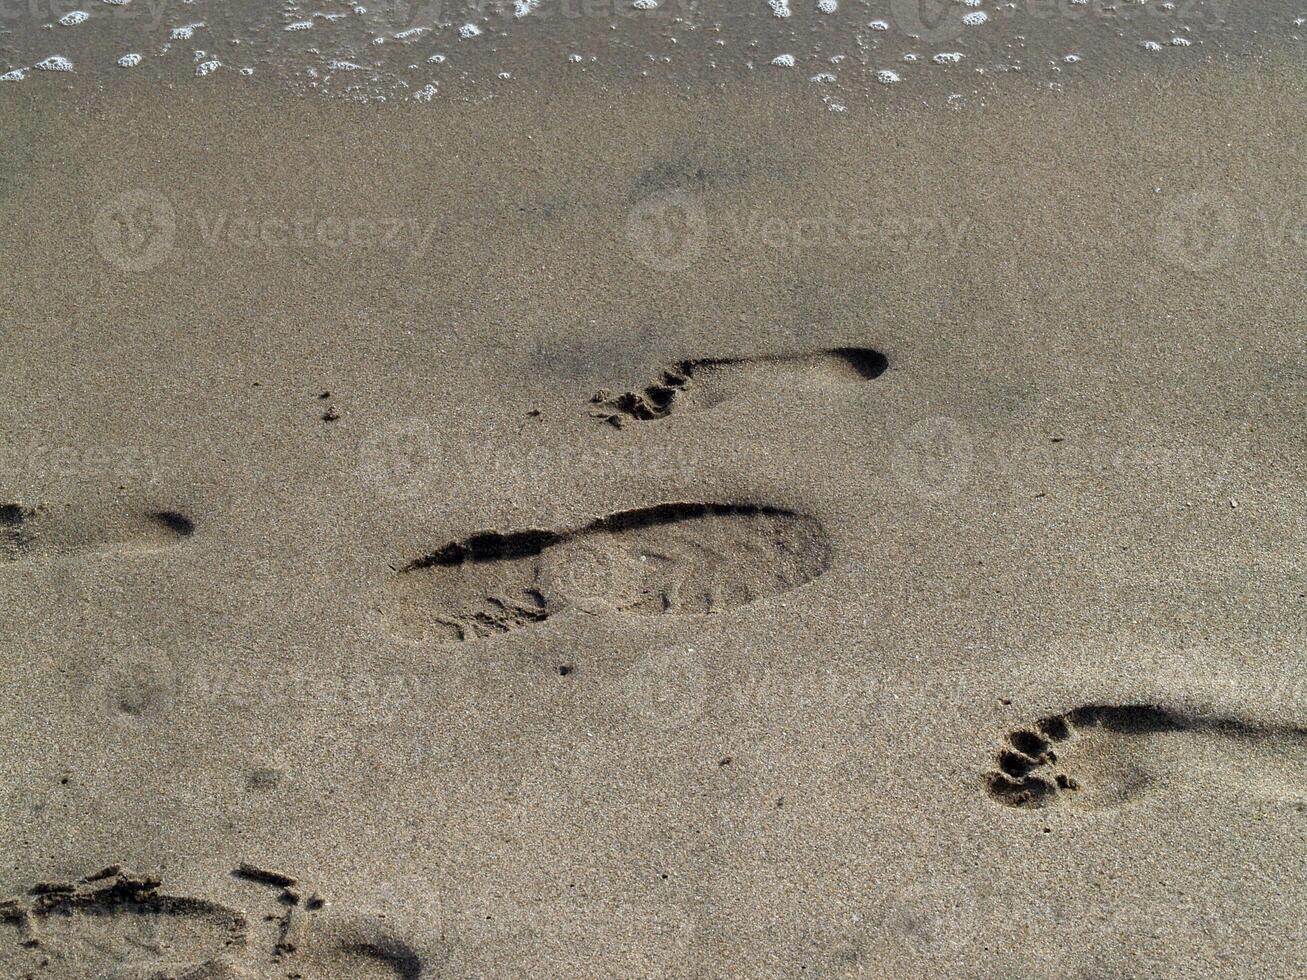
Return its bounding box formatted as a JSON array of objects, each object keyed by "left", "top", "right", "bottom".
[{"left": 985, "top": 704, "right": 1307, "bottom": 809}]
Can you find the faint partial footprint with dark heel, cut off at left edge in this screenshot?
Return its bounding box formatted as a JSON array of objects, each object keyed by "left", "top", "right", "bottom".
[{"left": 0, "top": 503, "right": 195, "bottom": 562}]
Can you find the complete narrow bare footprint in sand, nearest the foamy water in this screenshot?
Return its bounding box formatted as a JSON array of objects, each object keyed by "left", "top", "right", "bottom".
[{"left": 591, "top": 348, "right": 889, "bottom": 427}]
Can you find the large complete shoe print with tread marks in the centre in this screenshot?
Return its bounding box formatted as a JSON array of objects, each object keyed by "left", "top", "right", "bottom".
[{"left": 383, "top": 503, "right": 831, "bottom": 640}]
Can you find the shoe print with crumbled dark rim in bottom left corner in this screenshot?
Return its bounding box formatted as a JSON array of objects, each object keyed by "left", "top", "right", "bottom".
[{"left": 0, "top": 866, "right": 247, "bottom": 980}]
